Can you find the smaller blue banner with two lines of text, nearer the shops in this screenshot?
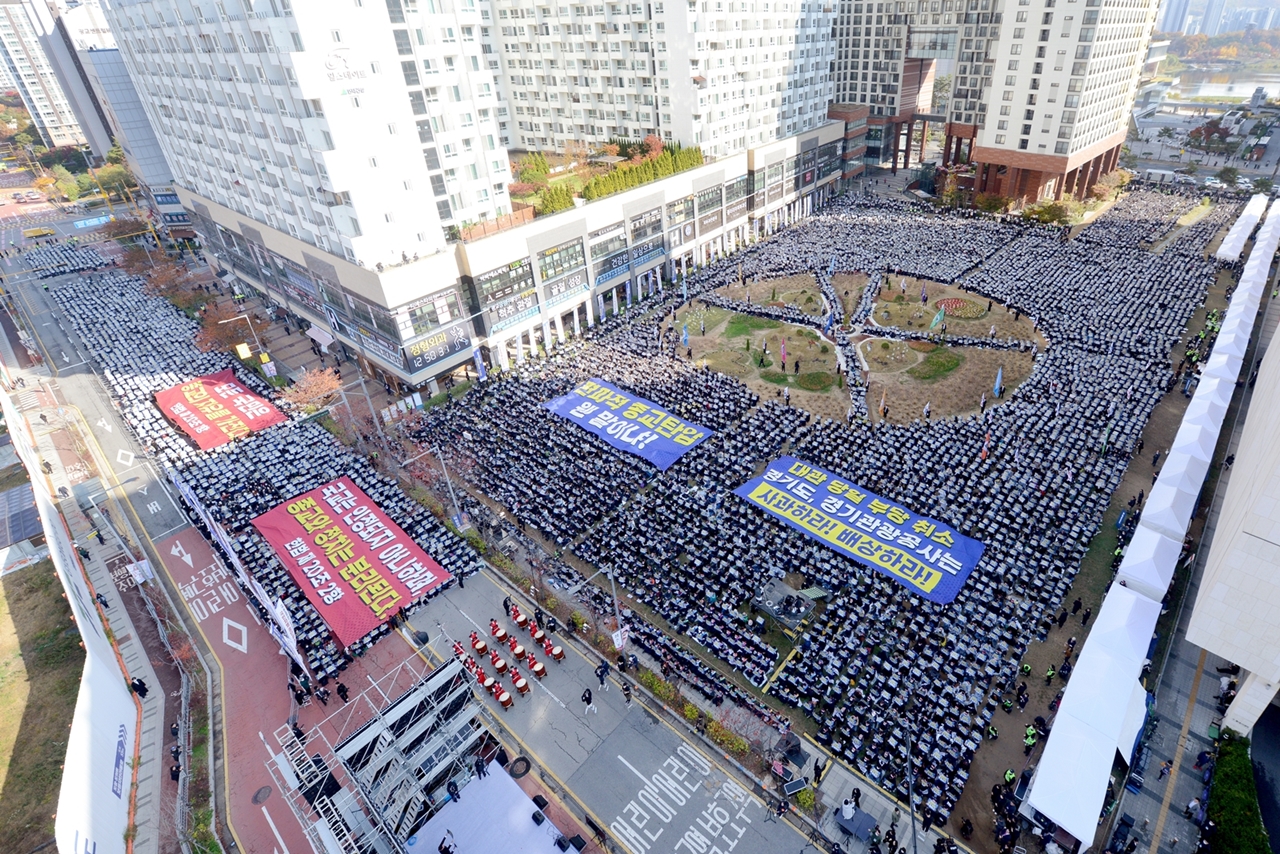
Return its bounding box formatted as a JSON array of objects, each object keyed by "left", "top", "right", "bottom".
[{"left": 543, "top": 379, "right": 712, "bottom": 471}]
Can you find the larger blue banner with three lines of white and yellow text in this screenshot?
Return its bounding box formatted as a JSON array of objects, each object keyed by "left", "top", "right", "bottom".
[{"left": 735, "top": 457, "right": 986, "bottom": 604}]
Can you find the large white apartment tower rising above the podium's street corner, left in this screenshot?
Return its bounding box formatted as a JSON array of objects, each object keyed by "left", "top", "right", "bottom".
[{"left": 101, "top": 0, "right": 511, "bottom": 263}]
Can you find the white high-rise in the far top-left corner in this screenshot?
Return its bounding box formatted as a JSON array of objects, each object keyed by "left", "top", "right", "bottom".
[{"left": 0, "top": 0, "right": 87, "bottom": 147}]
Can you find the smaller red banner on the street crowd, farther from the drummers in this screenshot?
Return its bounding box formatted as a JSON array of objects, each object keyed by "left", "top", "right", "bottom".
[{"left": 156, "top": 367, "right": 284, "bottom": 451}]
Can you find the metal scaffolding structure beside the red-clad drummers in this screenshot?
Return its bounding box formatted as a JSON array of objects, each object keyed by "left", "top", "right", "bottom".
[{"left": 268, "top": 656, "right": 488, "bottom": 854}]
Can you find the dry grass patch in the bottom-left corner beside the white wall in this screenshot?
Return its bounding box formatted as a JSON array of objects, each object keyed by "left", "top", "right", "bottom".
[{"left": 0, "top": 561, "right": 84, "bottom": 851}]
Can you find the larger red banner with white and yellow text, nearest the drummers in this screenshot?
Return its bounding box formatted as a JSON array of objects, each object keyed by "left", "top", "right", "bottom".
[{"left": 253, "top": 478, "right": 452, "bottom": 647}]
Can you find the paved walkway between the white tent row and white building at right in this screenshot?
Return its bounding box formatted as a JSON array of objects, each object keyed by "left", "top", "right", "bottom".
[{"left": 1117, "top": 245, "right": 1280, "bottom": 854}]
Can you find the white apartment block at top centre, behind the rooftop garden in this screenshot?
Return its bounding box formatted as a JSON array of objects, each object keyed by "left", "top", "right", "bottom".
[{"left": 493, "top": 0, "right": 835, "bottom": 157}]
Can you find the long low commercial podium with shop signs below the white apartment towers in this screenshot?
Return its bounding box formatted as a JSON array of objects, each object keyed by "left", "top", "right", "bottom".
[{"left": 194, "top": 110, "right": 865, "bottom": 393}]
